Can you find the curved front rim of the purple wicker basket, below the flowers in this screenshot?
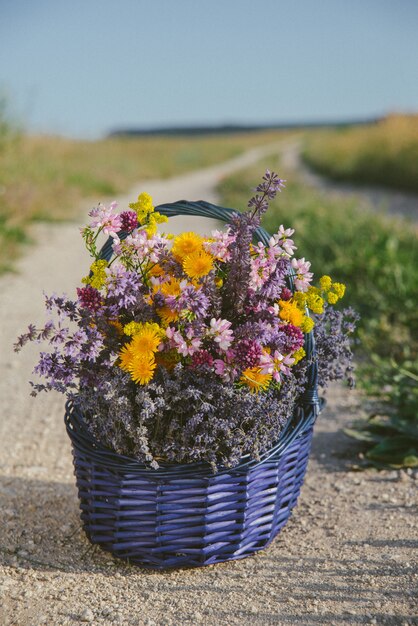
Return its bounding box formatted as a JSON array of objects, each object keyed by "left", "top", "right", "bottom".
[{"left": 64, "top": 399, "right": 325, "bottom": 478}]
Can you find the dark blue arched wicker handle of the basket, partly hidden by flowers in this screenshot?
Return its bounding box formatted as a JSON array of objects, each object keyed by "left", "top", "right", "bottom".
[{"left": 99, "top": 200, "right": 321, "bottom": 417}]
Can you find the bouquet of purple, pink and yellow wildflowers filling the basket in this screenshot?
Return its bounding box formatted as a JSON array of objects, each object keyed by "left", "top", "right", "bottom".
[{"left": 16, "top": 171, "right": 356, "bottom": 469}]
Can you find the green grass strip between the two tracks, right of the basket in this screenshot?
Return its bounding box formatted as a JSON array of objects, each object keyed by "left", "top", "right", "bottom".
[{"left": 219, "top": 159, "right": 418, "bottom": 467}]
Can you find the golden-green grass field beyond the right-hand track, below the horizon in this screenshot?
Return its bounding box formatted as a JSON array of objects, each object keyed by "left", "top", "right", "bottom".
[{"left": 303, "top": 115, "right": 418, "bottom": 193}]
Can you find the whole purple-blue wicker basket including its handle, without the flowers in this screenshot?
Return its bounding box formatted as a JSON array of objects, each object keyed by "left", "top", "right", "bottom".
[{"left": 65, "top": 201, "right": 321, "bottom": 569}]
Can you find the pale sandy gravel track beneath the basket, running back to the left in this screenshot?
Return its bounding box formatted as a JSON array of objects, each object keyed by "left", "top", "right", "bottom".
[{"left": 0, "top": 148, "right": 418, "bottom": 626}]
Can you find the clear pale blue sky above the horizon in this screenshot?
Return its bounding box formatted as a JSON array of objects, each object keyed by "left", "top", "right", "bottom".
[{"left": 0, "top": 0, "right": 418, "bottom": 138}]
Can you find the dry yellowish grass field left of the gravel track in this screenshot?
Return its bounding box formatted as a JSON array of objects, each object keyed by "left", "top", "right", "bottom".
[{"left": 0, "top": 111, "right": 283, "bottom": 273}]
